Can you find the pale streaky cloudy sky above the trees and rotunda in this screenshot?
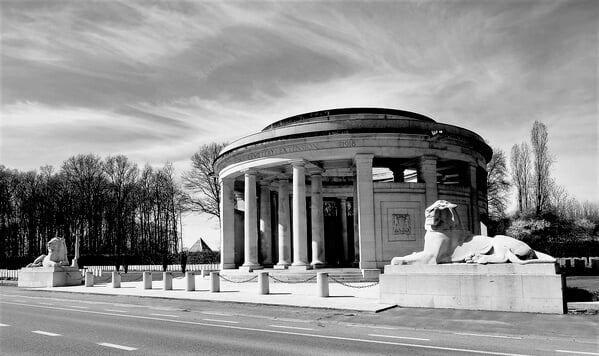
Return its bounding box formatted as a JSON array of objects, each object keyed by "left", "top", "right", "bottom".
[{"left": 0, "top": 0, "right": 599, "bottom": 248}]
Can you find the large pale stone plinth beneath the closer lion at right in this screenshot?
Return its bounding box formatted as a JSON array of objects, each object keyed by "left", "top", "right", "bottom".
[{"left": 380, "top": 263, "right": 566, "bottom": 314}]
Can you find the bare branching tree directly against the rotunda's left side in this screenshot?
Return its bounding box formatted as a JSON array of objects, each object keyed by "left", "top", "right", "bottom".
[{"left": 183, "top": 143, "right": 226, "bottom": 220}]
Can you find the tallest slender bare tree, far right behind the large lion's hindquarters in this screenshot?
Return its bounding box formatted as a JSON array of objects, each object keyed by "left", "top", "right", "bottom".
[{"left": 530, "top": 121, "right": 553, "bottom": 215}]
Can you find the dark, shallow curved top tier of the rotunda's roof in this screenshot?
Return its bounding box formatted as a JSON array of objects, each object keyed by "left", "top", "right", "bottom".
[{"left": 262, "top": 108, "right": 436, "bottom": 131}]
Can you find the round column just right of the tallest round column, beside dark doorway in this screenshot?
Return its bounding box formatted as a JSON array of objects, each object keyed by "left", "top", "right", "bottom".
[{"left": 310, "top": 173, "right": 325, "bottom": 267}]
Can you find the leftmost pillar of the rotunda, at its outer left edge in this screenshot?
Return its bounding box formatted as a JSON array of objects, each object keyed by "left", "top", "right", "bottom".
[{"left": 220, "top": 178, "right": 235, "bottom": 269}]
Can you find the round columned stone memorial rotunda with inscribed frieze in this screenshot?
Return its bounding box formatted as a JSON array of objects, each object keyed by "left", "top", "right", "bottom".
[{"left": 214, "top": 108, "right": 492, "bottom": 271}]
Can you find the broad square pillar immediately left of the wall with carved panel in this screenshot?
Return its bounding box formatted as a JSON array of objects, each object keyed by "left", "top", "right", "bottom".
[{"left": 354, "top": 154, "right": 376, "bottom": 269}]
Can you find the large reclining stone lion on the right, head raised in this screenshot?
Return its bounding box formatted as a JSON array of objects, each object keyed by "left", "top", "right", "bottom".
[{"left": 391, "top": 200, "right": 555, "bottom": 265}]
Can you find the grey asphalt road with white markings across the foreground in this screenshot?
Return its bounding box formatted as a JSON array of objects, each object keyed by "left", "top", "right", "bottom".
[{"left": 0, "top": 288, "right": 599, "bottom": 355}]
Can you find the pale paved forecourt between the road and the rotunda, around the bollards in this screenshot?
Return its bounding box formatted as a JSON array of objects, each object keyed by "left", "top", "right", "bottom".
[{"left": 36, "top": 275, "right": 395, "bottom": 312}]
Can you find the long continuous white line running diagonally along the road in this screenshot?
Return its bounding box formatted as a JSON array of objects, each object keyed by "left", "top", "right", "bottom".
[{"left": 0, "top": 302, "right": 529, "bottom": 356}]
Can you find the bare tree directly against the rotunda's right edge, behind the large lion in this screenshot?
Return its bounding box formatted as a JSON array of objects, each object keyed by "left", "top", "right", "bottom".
[{"left": 487, "top": 148, "right": 510, "bottom": 219}]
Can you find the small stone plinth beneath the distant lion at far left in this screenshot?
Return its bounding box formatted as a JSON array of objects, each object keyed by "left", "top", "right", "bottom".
[{"left": 18, "top": 266, "right": 81, "bottom": 288}]
